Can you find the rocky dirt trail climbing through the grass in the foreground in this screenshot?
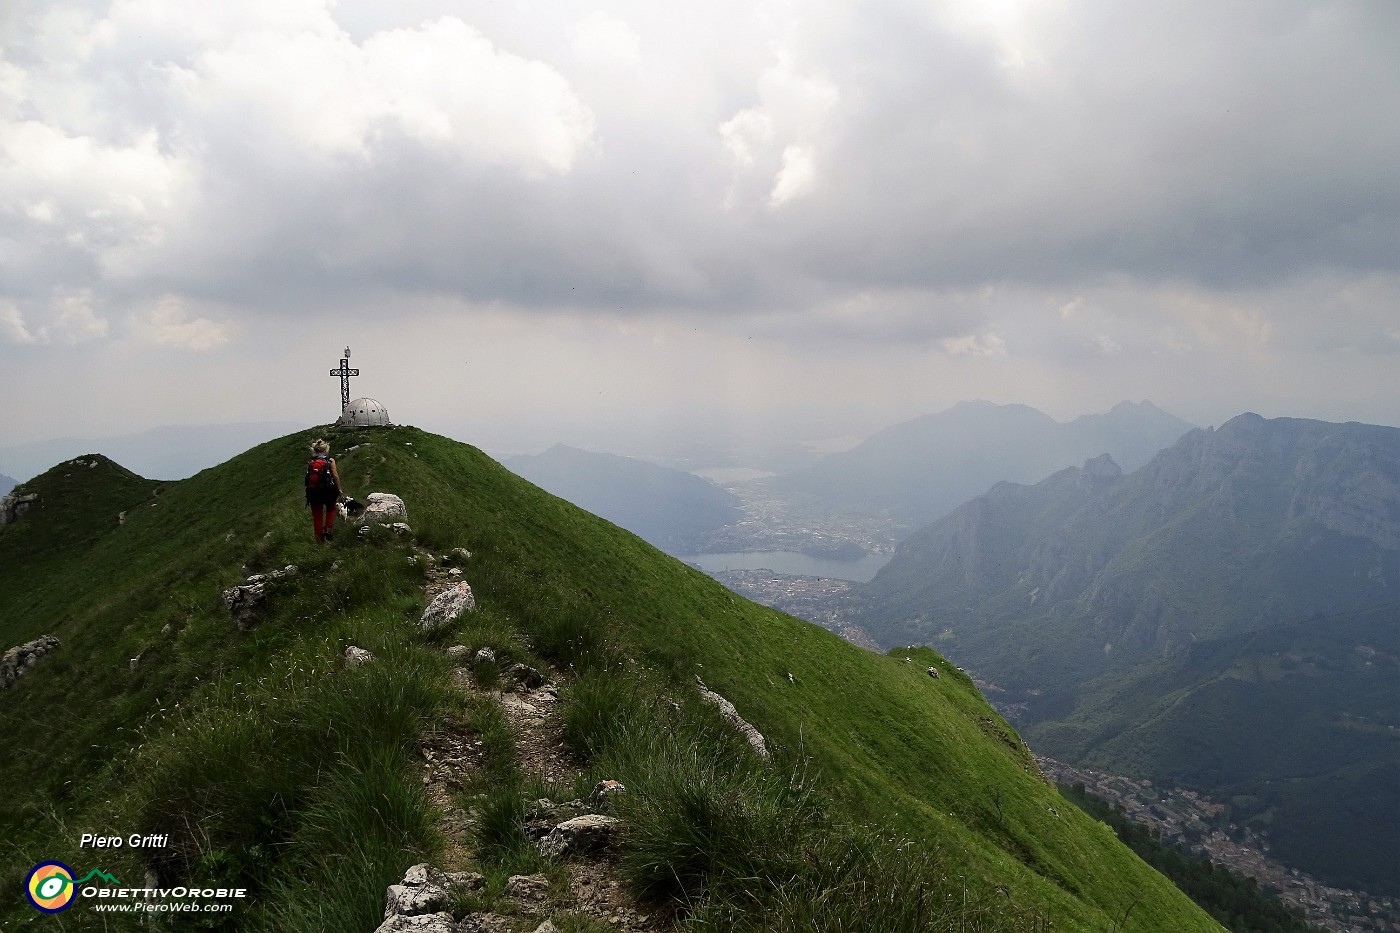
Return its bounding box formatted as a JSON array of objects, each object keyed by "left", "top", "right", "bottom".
[{"left": 374, "top": 526, "right": 672, "bottom": 933}]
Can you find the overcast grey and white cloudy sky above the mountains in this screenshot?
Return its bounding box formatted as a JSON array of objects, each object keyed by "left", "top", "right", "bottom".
[{"left": 0, "top": 0, "right": 1400, "bottom": 447}]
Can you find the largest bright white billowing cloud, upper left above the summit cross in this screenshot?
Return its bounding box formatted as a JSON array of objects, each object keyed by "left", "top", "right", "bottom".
[{"left": 169, "top": 17, "right": 592, "bottom": 174}]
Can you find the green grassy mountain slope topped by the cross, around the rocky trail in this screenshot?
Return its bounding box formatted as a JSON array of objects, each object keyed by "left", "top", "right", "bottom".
[{"left": 0, "top": 427, "right": 1219, "bottom": 933}]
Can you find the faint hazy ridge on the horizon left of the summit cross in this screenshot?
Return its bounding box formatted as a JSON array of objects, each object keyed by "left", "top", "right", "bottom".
[{"left": 0, "top": 422, "right": 305, "bottom": 481}]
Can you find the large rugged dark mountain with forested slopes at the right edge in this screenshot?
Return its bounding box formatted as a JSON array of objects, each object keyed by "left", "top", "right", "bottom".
[{"left": 855, "top": 415, "right": 1400, "bottom": 894}]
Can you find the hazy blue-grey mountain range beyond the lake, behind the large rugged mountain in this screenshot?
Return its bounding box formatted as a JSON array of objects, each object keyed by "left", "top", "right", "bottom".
[{"left": 771, "top": 401, "right": 1194, "bottom": 527}]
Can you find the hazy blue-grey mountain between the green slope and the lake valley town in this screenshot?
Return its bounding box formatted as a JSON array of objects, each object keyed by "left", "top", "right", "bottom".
[{"left": 503, "top": 444, "right": 743, "bottom": 553}]
